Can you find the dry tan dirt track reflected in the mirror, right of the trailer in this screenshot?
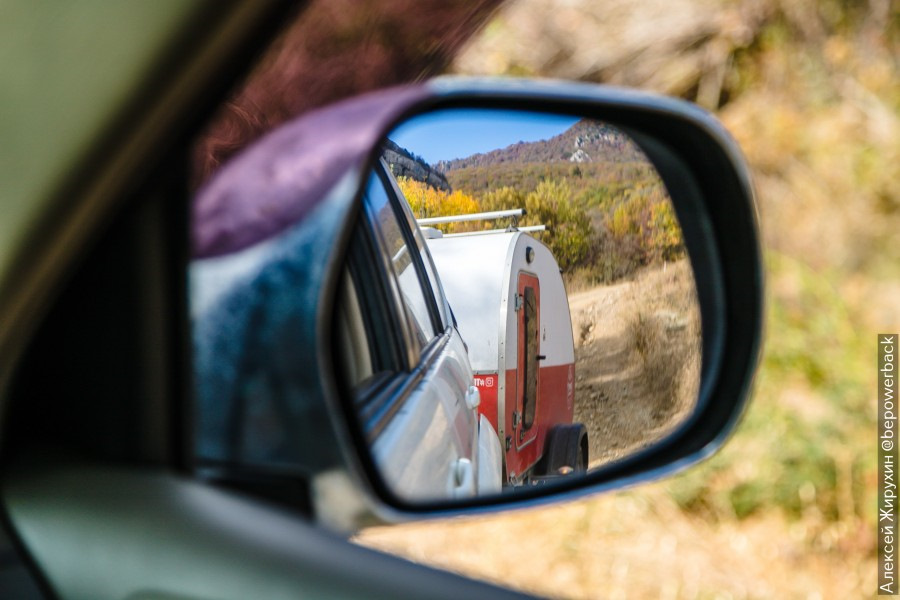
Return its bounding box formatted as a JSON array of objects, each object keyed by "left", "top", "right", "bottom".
[{"left": 569, "top": 260, "right": 700, "bottom": 467}]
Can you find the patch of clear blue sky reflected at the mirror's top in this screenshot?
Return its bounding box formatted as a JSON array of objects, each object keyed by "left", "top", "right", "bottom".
[{"left": 388, "top": 109, "right": 579, "bottom": 164}]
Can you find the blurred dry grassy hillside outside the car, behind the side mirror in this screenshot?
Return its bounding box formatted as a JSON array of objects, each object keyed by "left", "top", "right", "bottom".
[{"left": 348, "top": 0, "right": 900, "bottom": 598}]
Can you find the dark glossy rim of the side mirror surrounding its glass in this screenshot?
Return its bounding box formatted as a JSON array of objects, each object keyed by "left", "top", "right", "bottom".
[{"left": 337, "top": 78, "right": 763, "bottom": 515}]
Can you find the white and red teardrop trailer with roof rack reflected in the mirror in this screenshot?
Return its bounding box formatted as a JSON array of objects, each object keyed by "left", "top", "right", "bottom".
[{"left": 419, "top": 209, "right": 588, "bottom": 485}]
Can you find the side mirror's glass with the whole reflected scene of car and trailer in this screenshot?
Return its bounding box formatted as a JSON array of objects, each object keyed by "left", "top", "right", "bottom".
[{"left": 346, "top": 109, "right": 701, "bottom": 500}]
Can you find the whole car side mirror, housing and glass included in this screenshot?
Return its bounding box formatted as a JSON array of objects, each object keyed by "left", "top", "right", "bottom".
[{"left": 190, "top": 79, "right": 762, "bottom": 516}]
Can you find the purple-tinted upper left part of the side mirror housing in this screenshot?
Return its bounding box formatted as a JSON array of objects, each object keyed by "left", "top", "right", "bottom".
[{"left": 191, "top": 85, "right": 428, "bottom": 258}]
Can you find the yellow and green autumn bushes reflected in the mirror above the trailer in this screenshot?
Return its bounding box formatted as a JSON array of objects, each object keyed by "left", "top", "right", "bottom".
[{"left": 398, "top": 162, "right": 685, "bottom": 282}]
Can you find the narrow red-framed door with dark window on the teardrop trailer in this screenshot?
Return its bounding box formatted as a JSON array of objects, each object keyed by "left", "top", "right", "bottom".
[{"left": 513, "top": 273, "right": 541, "bottom": 450}]
